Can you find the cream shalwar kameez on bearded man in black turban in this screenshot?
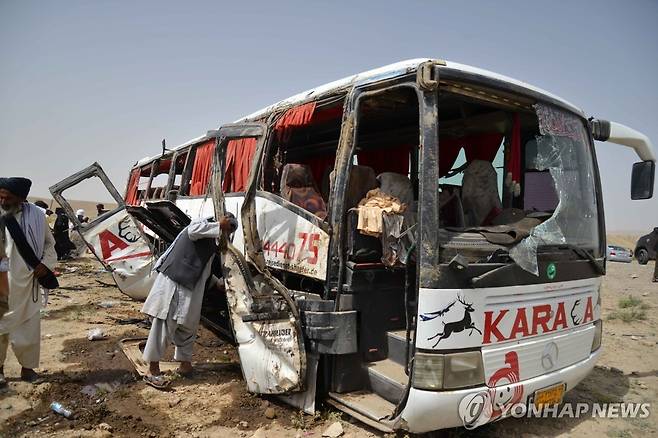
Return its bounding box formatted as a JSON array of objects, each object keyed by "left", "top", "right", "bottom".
[{"left": 0, "top": 203, "right": 57, "bottom": 369}]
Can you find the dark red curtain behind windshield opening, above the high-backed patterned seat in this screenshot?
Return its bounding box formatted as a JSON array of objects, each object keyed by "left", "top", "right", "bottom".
[{"left": 439, "top": 132, "right": 503, "bottom": 177}]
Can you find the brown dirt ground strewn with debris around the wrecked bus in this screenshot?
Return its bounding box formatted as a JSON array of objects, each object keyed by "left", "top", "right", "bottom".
[{"left": 0, "top": 255, "right": 658, "bottom": 438}]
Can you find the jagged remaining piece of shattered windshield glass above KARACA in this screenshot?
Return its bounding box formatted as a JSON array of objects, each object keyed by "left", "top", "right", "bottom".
[{"left": 509, "top": 103, "right": 600, "bottom": 275}]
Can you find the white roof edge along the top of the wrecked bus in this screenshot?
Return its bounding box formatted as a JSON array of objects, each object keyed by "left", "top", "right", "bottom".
[{"left": 136, "top": 58, "right": 584, "bottom": 166}]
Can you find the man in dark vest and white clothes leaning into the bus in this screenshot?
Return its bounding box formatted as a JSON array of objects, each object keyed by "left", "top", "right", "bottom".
[{"left": 142, "top": 214, "right": 238, "bottom": 389}]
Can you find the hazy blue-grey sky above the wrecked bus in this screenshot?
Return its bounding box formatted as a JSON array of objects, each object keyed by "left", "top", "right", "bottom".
[{"left": 0, "top": 0, "right": 658, "bottom": 232}]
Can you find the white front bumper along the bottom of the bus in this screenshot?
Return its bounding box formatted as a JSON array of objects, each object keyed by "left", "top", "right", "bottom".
[{"left": 398, "top": 348, "right": 601, "bottom": 433}]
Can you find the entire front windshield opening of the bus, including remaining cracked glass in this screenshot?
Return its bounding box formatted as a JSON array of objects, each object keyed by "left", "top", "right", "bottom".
[{"left": 439, "top": 94, "right": 601, "bottom": 275}]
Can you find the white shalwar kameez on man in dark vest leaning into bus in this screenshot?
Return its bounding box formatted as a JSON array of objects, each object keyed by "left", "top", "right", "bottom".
[{"left": 142, "top": 220, "right": 220, "bottom": 362}]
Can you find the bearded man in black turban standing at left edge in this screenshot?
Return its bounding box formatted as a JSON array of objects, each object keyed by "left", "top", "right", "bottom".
[{"left": 0, "top": 177, "right": 57, "bottom": 382}]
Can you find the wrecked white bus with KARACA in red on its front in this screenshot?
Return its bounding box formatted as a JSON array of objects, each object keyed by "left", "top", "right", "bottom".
[{"left": 52, "top": 59, "right": 655, "bottom": 432}]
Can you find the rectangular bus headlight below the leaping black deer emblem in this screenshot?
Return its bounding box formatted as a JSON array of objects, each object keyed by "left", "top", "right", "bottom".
[{"left": 412, "top": 351, "right": 484, "bottom": 390}]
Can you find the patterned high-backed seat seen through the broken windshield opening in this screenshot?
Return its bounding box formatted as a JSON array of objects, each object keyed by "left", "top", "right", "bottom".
[{"left": 462, "top": 160, "right": 502, "bottom": 227}]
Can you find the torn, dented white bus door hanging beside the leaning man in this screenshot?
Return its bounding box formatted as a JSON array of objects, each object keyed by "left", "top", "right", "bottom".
[{"left": 209, "top": 123, "right": 306, "bottom": 394}]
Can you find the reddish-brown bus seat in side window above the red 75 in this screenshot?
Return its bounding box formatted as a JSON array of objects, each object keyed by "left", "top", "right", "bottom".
[{"left": 281, "top": 163, "right": 327, "bottom": 219}]
